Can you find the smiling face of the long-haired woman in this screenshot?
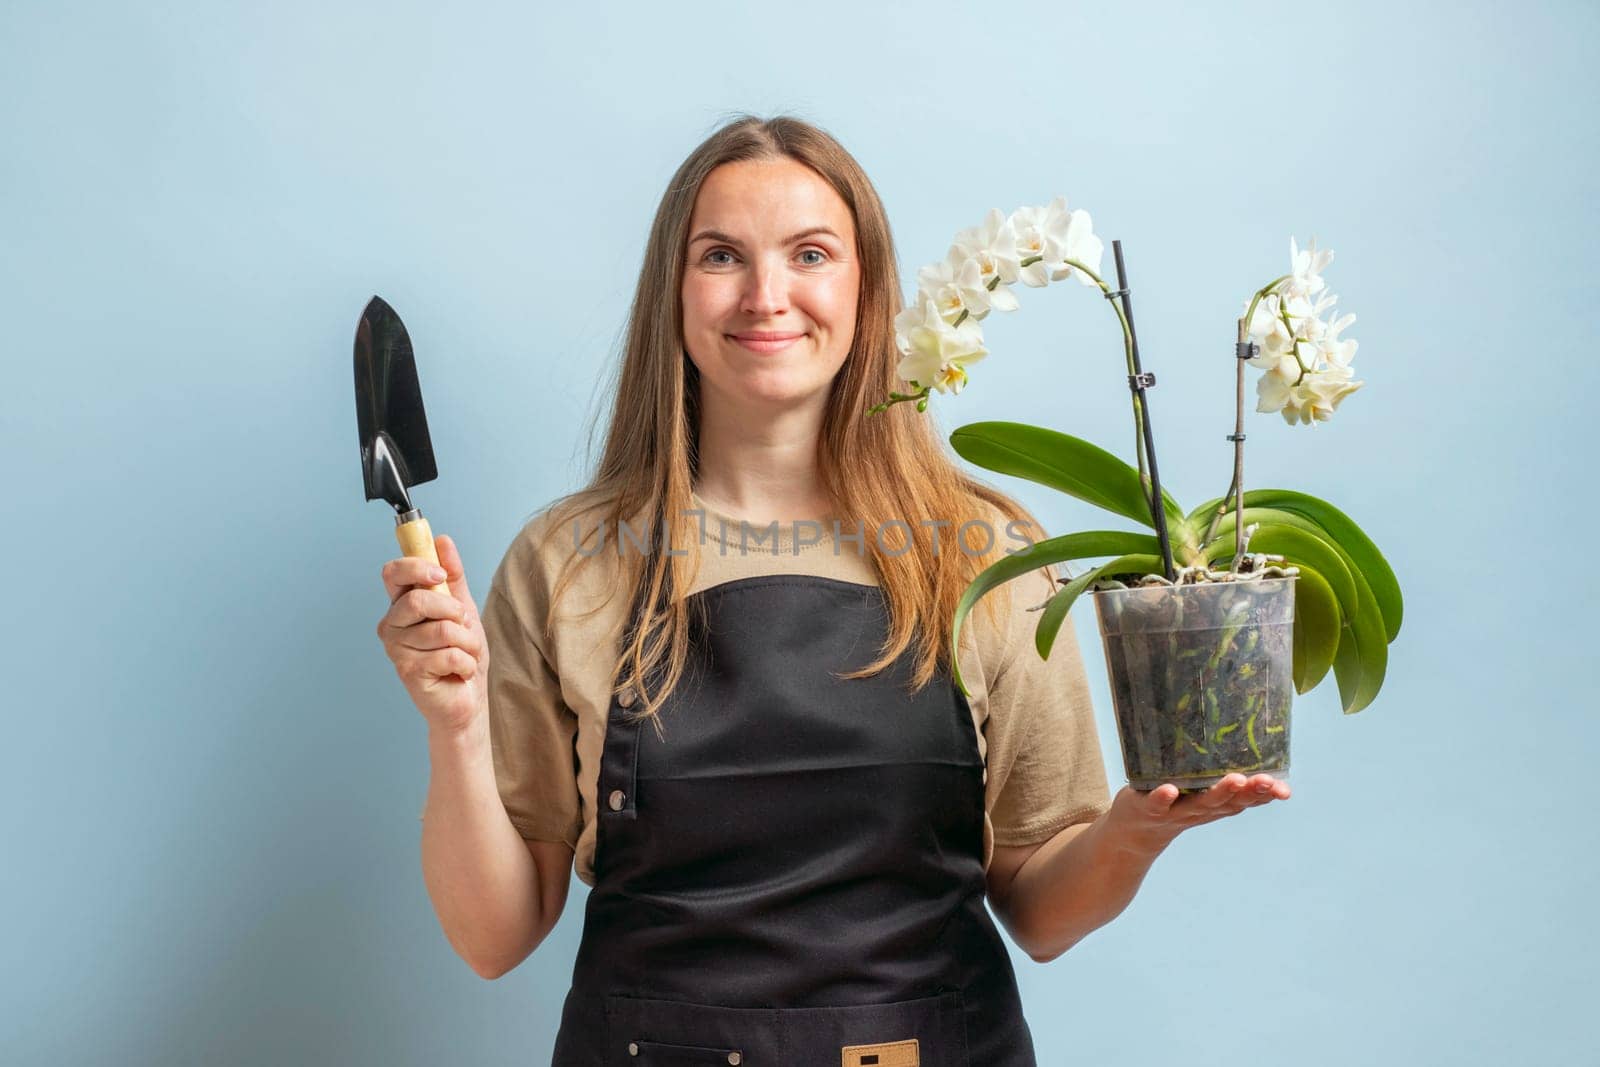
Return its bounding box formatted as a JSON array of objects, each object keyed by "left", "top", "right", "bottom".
[{"left": 683, "top": 158, "right": 861, "bottom": 406}]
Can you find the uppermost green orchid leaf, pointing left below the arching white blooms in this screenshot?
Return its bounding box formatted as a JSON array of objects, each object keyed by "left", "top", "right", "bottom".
[{"left": 950, "top": 421, "right": 1184, "bottom": 526}]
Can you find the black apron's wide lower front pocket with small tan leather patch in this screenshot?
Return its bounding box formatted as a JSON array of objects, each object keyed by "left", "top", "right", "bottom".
[{"left": 605, "top": 990, "right": 968, "bottom": 1067}]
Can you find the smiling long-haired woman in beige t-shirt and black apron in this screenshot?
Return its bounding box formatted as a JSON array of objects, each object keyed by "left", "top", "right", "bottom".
[{"left": 379, "top": 117, "right": 1288, "bottom": 1067}]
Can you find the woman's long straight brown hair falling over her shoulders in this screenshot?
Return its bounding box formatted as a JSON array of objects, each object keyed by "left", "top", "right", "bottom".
[{"left": 546, "top": 115, "right": 1043, "bottom": 717}]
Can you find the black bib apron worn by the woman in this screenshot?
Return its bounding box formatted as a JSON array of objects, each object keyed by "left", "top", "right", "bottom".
[{"left": 554, "top": 574, "right": 1035, "bottom": 1067}]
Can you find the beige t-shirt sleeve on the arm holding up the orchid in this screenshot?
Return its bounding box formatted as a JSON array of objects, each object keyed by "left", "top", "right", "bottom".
[{"left": 987, "top": 568, "right": 1110, "bottom": 845}]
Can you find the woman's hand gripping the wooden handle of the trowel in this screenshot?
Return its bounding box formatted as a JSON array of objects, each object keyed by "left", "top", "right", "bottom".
[{"left": 378, "top": 536, "right": 490, "bottom": 731}]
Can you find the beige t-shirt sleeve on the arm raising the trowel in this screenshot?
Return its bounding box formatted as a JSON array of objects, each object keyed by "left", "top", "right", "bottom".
[{"left": 483, "top": 550, "right": 582, "bottom": 849}]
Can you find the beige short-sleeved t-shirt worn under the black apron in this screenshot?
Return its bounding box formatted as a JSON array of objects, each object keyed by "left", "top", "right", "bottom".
[{"left": 435, "top": 494, "right": 1110, "bottom": 886}]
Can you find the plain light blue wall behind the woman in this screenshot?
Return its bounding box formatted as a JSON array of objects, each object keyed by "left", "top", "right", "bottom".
[{"left": 0, "top": 0, "right": 1600, "bottom": 1064}]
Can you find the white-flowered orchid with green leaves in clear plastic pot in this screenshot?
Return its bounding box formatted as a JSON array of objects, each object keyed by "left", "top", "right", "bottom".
[{"left": 872, "top": 197, "right": 1402, "bottom": 792}]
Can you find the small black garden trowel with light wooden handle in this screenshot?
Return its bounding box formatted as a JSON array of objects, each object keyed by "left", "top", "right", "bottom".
[{"left": 355, "top": 296, "right": 450, "bottom": 593}]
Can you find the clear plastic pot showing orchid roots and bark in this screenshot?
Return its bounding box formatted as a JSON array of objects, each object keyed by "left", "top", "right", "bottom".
[{"left": 1093, "top": 577, "right": 1294, "bottom": 792}]
